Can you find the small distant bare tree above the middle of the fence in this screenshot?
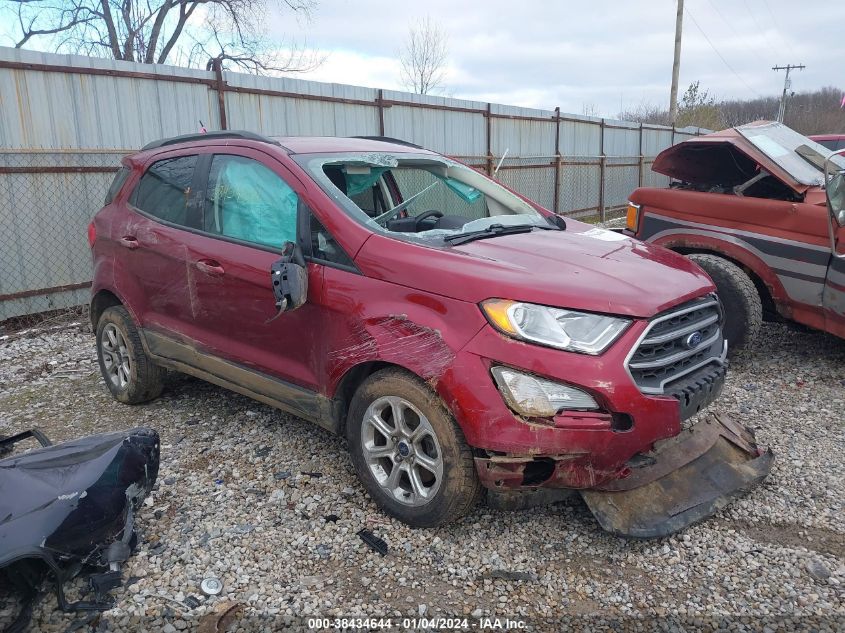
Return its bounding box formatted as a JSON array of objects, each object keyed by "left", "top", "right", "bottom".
[{"left": 399, "top": 17, "right": 449, "bottom": 95}]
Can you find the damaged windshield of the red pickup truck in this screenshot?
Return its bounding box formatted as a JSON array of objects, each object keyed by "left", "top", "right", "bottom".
[{"left": 736, "top": 123, "right": 845, "bottom": 186}]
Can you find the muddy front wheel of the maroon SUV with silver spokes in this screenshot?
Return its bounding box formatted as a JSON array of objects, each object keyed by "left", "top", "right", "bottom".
[{"left": 346, "top": 369, "right": 482, "bottom": 527}]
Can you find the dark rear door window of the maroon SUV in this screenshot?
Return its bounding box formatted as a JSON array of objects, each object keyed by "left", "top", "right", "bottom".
[{"left": 130, "top": 156, "right": 197, "bottom": 225}]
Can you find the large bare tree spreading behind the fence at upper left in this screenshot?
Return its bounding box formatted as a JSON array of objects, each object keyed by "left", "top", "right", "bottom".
[{"left": 5, "top": 0, "right": 319, "bottom": 73}]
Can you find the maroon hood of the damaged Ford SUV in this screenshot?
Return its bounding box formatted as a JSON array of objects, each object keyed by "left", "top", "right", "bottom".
[{"left": 356, "top": 220, "right": 714, "bottom": 317}]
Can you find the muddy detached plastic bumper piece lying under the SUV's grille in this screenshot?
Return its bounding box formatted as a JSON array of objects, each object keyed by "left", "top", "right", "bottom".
[{"left": 581, "top": 415, "right": 774, "bottom": 538}]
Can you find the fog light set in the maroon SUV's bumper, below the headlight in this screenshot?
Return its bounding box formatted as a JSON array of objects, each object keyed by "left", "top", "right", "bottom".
[{"left": 490, "top": 367, "right": 599, "bottom": 418}]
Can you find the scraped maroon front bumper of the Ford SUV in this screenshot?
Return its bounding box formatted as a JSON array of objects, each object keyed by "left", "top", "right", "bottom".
[{"left": 452, "top": 321, "right": 724, "bottom": 489}]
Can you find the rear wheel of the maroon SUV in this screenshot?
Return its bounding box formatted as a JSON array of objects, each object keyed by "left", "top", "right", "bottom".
[{"left": 97, "top": 306, "right": 165, "bottom": 404}]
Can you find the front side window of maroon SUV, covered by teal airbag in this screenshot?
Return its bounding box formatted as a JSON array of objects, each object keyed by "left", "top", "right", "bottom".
[{"left": 203, "top": 154, "right": 299, "bottom": 248}]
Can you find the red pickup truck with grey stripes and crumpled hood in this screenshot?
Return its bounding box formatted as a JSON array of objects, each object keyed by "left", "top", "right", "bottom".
[{"left": 624, "top": 121, "right": 845, "bottom": 350}]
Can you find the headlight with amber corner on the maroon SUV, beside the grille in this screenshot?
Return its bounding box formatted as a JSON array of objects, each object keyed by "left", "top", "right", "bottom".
[{"left": 481, "top": 299, "right": 631, "bottom": 354}]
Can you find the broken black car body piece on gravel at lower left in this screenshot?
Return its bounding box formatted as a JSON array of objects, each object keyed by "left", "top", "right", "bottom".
[{"left": 0, "top": 428, "right": 159, "bottom": 631}]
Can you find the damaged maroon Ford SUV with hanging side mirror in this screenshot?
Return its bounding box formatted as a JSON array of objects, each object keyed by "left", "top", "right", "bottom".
[{"left": 89, "top": 132, "right": 772, "bottom": 536}]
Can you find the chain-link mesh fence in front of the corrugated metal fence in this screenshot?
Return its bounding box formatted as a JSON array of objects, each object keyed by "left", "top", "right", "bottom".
[{"left": 0, "top": 150, "right": 667, "bottom": 321}]
